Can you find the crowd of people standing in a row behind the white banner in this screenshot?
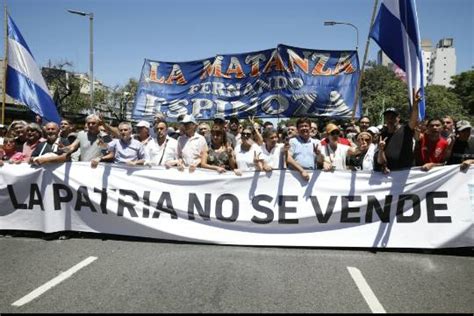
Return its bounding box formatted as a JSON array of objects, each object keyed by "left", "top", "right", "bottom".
[{"left": 0, "top": 108, "right": 474, "bottom": 181}]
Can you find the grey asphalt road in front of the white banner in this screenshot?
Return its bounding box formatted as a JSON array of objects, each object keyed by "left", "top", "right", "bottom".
[{"left": 0, "top": 232, "right": 474, "bottom": 313}]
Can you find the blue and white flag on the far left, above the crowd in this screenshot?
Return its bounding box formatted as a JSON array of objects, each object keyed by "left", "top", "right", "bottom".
[{"left": 6, "top": 16, "right": 61, "bottom": 124}]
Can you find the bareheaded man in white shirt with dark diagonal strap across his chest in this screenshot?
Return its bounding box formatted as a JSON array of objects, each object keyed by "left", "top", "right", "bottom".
[{"left": 145, "top": 121, "right": 178, "bottom": 166}]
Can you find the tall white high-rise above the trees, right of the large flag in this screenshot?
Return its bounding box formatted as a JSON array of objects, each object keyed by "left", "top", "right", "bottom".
[{"left": 428, "top": 38, "right": 456, "bottom": 88}]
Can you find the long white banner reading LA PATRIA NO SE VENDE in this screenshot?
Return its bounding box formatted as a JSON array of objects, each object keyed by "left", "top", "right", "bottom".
[{"left": 0, "top": 163, "right": 474, "bottom": 248}]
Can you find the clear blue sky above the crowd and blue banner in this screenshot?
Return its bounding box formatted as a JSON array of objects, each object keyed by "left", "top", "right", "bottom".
[{"left": 1, "top": 0, "right": 474, "bottom": 86}]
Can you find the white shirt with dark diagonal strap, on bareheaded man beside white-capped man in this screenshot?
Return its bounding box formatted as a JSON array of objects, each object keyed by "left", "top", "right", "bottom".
[{"left": 145, "top": 136, "right": 178, "bottom": 166}]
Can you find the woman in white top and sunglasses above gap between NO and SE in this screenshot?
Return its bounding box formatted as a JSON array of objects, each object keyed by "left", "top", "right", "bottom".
[{"left": 234, "top": 127, "right": 263, "bottom": 176}]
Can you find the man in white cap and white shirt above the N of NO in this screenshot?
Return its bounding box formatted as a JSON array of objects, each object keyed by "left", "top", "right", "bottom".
[{"left": 173, "top": 114, "right": 207, "bottom": 172}]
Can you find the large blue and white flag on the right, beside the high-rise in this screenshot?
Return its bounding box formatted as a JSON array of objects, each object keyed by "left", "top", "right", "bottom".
[{"left": 370, "top": 0, "right": 425, "bottom": 120}]
